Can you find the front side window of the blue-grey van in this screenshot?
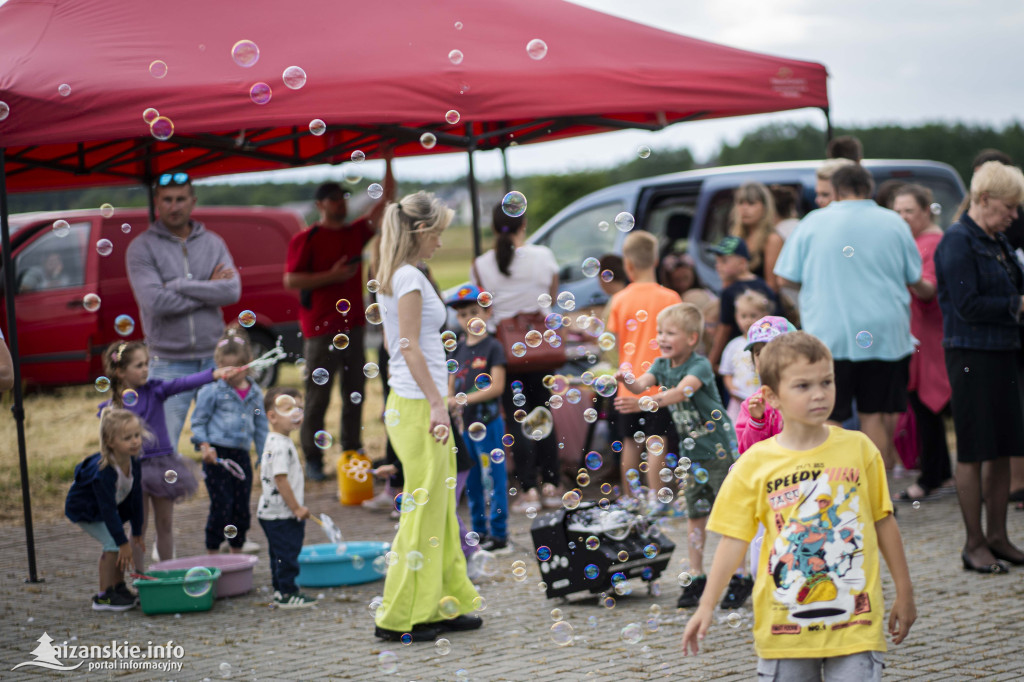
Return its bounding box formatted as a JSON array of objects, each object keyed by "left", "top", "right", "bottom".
[{"left": 537, "top": 202, "right": 625, "bottom": 283}]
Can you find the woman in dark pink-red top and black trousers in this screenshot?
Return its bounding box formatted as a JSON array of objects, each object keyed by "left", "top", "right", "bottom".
[{"left": 891, "top": 184, "right": 952, "bottom": 502}]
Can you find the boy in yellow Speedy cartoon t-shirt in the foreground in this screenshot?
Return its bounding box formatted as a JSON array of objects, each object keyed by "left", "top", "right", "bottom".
[{"left": 682, "top": 332, "right": 916, "bottom": 681}]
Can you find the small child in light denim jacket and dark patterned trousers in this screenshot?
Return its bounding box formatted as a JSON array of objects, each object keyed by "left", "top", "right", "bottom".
[{"left": 191, "top": 327, "right": 268, "bottom": 554}]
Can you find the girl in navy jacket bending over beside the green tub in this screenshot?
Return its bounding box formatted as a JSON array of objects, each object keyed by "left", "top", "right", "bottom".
[{"left": 65, "top": 408, "right": 152, "bottom": 611}]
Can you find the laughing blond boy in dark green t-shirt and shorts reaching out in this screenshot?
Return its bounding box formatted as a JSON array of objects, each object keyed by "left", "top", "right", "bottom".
[{"left": 620, "top": 303, "right": 736, "bottom": 608}]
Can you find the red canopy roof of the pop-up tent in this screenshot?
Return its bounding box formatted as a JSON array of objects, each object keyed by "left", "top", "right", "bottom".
[{"left": 0, "top": 0, "right": 828, "bottom": 190}]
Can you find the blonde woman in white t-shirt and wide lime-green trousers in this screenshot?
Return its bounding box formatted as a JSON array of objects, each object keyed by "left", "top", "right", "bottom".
[{"left": 375, "top": 191, "right": 482, "bottom": 641}]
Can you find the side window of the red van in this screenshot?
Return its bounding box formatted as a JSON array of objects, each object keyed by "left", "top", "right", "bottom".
[{"left": 14, "top": 222, "right": 92, "bottom": 294}]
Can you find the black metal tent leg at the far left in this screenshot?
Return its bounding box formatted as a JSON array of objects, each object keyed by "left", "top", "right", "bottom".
[{"left": 0, "top": 147, "right": 42, "bottom": 583}]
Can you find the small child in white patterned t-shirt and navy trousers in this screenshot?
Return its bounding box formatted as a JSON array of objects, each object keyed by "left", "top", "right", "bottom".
[{"left": 256, "top": 387, "right": 316, "bottom": 608}]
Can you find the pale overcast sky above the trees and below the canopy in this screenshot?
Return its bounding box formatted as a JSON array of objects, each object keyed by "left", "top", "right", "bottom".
[{"left": 203, "top": 0, "right": 1024, "bottom": 186}]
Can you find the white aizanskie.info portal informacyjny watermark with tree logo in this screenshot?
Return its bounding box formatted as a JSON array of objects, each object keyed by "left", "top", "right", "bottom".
[{"left": 11, "top": 632, "right": 185, "bottom": 673}]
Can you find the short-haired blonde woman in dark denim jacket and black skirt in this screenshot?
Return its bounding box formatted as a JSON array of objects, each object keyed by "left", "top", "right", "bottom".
[{"left": 935, "top": 161, "right": 1024, "bottom": 573}]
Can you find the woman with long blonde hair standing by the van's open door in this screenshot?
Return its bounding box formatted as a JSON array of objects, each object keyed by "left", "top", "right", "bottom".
[{"left": 729, "top": 182, "right": 783, "bottom": 292}]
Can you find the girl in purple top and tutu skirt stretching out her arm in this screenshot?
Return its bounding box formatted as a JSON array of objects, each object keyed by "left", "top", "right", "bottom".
[{"left": 97, "top": 341, "right": 236, "bottom": 570}]
